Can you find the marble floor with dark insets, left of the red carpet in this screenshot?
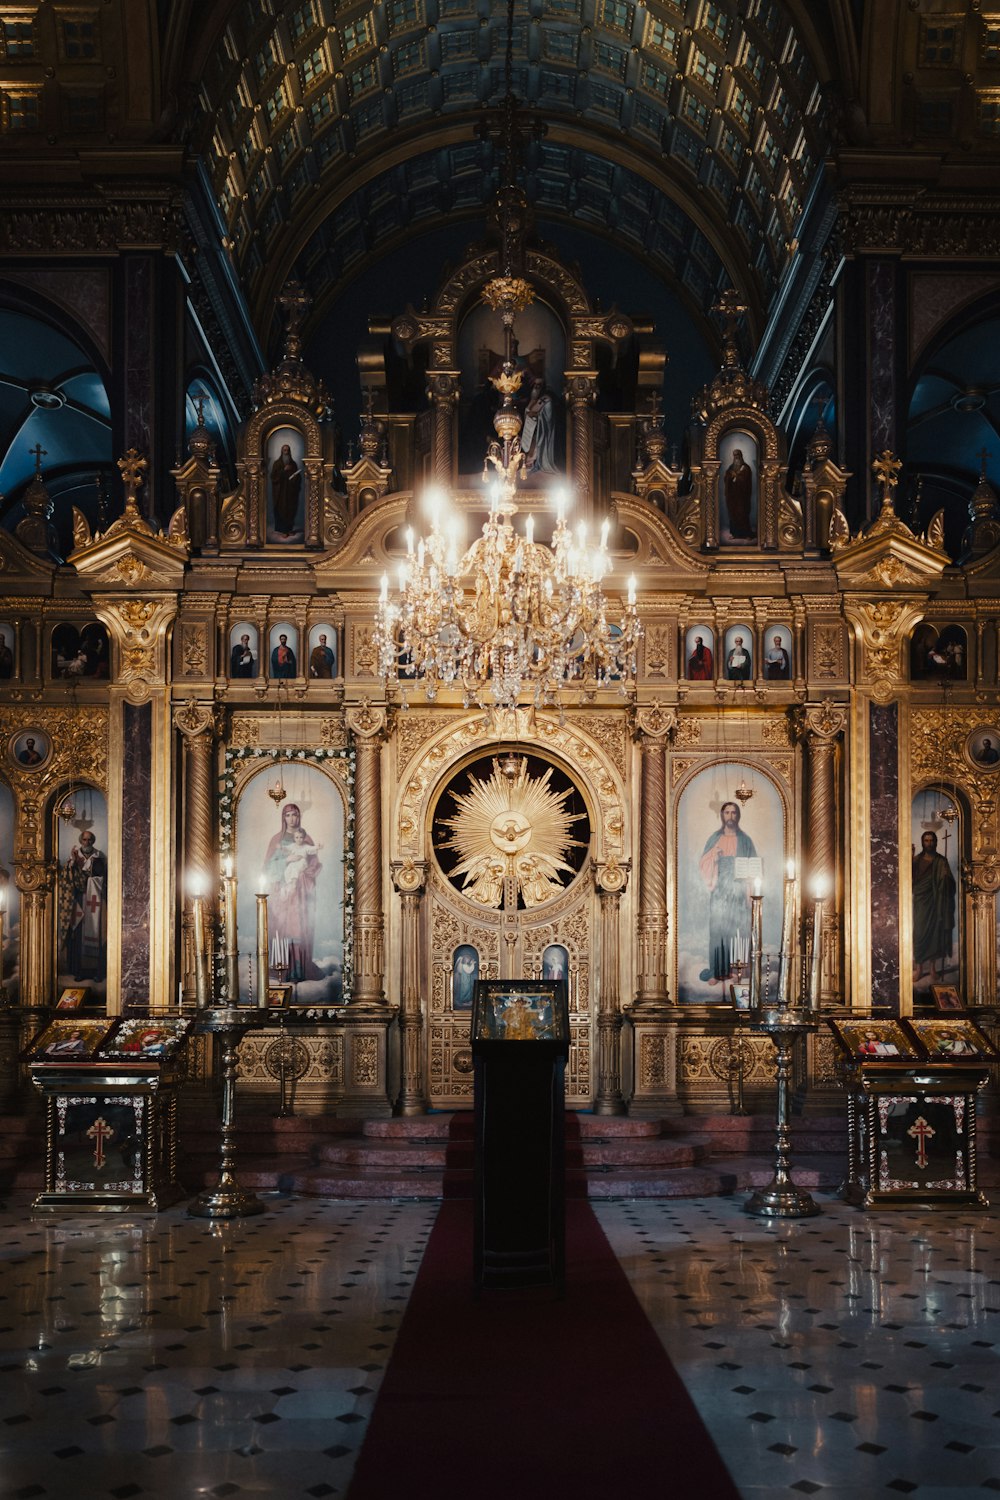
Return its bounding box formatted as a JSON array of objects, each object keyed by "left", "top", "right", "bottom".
[{"left": 0, "top": 1194, "right": 436, "bottom": 1500}]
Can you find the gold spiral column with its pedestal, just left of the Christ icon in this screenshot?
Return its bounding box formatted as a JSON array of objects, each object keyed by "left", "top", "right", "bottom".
[{"left": 628, "top": 704, "right": 682, "bottom": 1119}]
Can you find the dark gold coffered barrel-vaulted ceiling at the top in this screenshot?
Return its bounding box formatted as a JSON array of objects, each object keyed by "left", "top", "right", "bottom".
[{"left": 187, "top": 0, "right": 826, "bottom": 340}]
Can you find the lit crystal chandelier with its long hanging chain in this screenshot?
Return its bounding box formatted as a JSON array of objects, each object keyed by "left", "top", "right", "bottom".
[{"left": 375, "top": 3, "right": 642, "bottom": 710}]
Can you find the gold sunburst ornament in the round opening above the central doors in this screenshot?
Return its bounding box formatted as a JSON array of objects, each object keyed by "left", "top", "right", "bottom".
[{"left": 441, "top": 752, "right": 585, "bottom": 906}]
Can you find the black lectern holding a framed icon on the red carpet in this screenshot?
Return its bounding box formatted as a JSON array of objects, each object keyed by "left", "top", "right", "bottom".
[{"left": 472, "top": 980, "right": 570, "bottom": 1290}]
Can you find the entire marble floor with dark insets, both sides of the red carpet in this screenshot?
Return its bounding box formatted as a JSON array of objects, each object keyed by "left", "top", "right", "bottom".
[{"left": 0, "top": 1194, "right": 1000, "bottom": 1500}]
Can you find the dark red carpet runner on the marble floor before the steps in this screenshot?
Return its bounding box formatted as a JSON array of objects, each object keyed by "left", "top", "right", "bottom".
[{"left": 348, "top": 1202, "right": 738, "bottom": 1500}]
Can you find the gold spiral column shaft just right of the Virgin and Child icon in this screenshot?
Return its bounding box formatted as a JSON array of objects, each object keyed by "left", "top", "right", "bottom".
[{"left": 346, "top": 704, "right": 385, "bottom": 1008}]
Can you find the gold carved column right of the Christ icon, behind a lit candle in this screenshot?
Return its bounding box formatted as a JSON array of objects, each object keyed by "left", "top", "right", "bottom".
[{"left": 798, "top": 702, "right": 847, "bottom": 1004}]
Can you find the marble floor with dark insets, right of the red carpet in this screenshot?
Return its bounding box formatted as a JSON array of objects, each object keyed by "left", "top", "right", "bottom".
[{"left": 595, "top": 1197, "right": 1000, "bottom": 1500}]
